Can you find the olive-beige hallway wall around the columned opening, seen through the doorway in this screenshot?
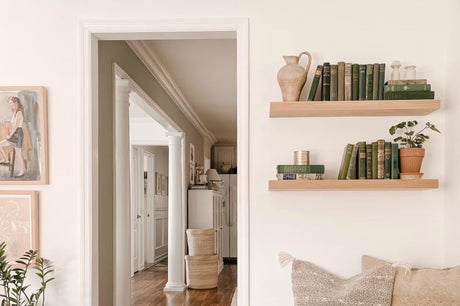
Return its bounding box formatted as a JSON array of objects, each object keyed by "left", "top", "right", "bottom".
[{"left": 99, "top": 41, "right": 203, "bottom": 305}]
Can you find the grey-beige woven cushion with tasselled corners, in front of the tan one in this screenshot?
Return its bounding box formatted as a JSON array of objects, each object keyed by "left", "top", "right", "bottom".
[{"left": 292, "top": 259, "right": 394, "bottom": 306}]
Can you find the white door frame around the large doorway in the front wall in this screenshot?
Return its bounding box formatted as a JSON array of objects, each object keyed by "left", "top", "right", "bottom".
[{"left": 78, "top": 18, "right": 250, "bottom": 305}]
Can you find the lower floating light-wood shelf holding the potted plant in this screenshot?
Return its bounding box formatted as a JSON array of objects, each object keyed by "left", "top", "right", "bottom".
[{"left": 268, "top": 179, "right": 439, "bottom": 190}]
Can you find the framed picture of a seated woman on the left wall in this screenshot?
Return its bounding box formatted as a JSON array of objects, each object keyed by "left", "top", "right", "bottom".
[{"left": 0, "top": 87, "right": 48, "bottom": 184}]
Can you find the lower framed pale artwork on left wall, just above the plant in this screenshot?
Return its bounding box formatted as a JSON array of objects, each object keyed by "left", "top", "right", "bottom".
[{"left": 0, "top": 191, "right": 38, "bottom": 262}]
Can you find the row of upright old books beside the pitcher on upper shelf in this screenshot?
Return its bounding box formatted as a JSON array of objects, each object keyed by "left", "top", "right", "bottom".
[{"left": 307, "top": 62, "right": 385, "bottom": 101}]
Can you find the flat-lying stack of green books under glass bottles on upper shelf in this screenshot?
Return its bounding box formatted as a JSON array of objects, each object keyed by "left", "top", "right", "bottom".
[{"left": 384, "top": 79, "right": 434, "bottom": 100}]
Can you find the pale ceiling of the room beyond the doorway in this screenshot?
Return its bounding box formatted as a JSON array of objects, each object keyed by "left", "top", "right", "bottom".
[{"left": 140, "top": 39, "right": 237, "bottom": 143}]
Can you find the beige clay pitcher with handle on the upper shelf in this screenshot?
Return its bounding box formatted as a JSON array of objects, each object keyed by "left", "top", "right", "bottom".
[{"left": 278, "top": 51, "right": 311, "bottom": 102}]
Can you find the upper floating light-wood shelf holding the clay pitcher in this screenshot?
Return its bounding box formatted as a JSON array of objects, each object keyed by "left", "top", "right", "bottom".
[{"left": 270, "top": 100, "right": 441, "bottom": 118}]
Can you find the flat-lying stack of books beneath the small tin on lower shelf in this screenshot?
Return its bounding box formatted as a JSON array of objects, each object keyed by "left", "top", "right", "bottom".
[{"left": 276, "top": 165, "right": 324, "bottom": 181}]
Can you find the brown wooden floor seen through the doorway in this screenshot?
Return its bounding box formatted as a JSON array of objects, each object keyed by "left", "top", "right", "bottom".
[{"left": 131, "top": 264, "right": 236, "bottom": 306}]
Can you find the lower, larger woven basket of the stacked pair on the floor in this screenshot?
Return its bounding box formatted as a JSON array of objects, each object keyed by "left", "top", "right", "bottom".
[{"left": 185, "top": 254, "right": 218, "bottom": 289}]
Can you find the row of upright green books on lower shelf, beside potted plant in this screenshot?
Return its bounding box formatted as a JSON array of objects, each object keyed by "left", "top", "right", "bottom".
[{"left": 338, "top": 139, "right": 399, "bottom": 180}]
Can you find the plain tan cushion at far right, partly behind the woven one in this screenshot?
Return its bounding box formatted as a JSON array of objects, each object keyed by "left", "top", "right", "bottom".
[{"left": 361, "top": 255, "right": 460, "bottom": 306}]
